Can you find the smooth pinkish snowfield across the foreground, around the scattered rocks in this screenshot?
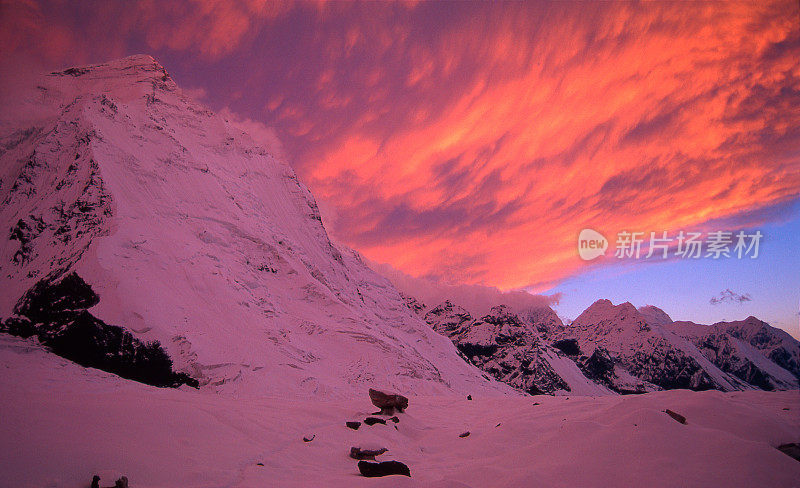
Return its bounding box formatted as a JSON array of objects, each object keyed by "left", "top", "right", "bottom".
[{"left": 0, "top": 336, "right": 800, "bottom": 488}]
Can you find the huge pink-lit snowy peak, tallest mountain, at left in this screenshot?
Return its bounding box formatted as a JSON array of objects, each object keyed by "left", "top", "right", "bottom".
[{"left": 0, "top": 55, "right": 511, "bottom": 396}]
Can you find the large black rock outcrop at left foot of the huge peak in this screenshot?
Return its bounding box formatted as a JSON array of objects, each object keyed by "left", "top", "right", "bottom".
[{"left": 3, "top": 272, "right": 198, "bottom": 387}]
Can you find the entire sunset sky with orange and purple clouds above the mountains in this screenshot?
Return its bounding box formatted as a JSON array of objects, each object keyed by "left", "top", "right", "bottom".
[{"left": 0, "top": 0, "right": 800, "bottom": 337}]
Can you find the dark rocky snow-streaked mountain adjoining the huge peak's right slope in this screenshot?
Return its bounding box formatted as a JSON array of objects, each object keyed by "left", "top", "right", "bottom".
[{"left": 407, "top": 298, "right": 611, "bottom": 395}]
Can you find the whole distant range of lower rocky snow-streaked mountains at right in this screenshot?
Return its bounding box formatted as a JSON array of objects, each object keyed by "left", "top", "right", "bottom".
[{"left": 406, "top": 297, "right": 800, "bottom": 394}]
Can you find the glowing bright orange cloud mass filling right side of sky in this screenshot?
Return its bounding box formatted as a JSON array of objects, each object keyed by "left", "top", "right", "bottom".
[{"left": 296, "top": 3, "right": 800, "bottom": 289}]
